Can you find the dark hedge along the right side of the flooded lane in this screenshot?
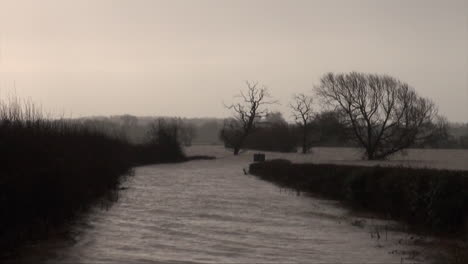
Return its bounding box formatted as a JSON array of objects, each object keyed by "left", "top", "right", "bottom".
[{"left": 250, "top": 160, "right": 468, "bottom": 235}]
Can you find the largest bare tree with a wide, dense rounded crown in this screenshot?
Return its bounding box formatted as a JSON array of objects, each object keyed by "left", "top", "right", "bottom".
[{"left": 316, "top": 72, "right": 438, "bottom": 160}]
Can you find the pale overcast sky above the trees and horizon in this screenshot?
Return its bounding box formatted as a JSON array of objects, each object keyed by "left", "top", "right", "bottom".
[{"left": 0, "top": 0, "right": 468, "bottom": 122}]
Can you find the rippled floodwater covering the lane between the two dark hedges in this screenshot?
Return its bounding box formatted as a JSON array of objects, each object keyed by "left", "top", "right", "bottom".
[{"left": 8, "top": 149, "right": 450, "bottom": 263}]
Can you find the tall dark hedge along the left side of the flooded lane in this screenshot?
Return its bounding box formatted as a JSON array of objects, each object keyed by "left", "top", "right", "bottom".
[{"left": 0, "top": 99, "right": 186, "bottom": 252}]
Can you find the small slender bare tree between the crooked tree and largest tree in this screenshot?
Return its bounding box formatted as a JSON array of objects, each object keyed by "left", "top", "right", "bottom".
[{"left": 289, "top": 94, "right": 313, "bottom": 154}]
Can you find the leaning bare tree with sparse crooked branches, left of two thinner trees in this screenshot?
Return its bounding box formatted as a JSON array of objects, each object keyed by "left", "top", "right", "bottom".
[{"left": 220, "top": 81, "right": 277, "bottom": 155}]
